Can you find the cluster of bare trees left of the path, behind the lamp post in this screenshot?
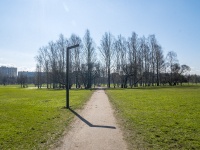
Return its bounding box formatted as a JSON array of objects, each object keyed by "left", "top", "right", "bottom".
[{"left": 36, "top": 30, "right": 99, "bottom": 88}]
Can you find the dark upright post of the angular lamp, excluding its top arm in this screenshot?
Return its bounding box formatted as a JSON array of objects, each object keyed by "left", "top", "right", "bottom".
[{"left": 66, "top": 48, "right": 69, "bottom": 109}]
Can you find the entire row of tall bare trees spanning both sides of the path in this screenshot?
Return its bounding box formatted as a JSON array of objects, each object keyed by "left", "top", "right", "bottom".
[{"left": 36, "top": 30, "right": 190, "bottom": 88}]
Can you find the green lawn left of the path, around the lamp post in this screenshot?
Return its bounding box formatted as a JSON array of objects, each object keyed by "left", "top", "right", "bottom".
[{"left": 0, "top": 86, "right": 92, "bottom": 149}]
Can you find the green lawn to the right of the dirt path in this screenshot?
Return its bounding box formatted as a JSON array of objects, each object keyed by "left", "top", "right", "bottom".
[{"left": 107, "top": 86, "right": 200, "bottom": 150}]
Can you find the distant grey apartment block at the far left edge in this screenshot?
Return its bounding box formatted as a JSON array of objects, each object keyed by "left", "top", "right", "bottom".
[{"left": 0, "top": 66, "right": 17, "bottom": 77}]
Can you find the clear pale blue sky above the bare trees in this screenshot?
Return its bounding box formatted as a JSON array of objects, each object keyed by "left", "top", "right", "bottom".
[{"left": 0, "top": 0, "right": 200, "bottom": 75}]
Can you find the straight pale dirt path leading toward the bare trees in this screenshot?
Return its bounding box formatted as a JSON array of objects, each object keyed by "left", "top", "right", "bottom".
[{"left": 56, "top": 90, "right": 127, "bottom": 150}]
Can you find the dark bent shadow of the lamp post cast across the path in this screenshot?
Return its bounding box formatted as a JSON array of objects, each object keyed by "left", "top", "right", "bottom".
[{"left": 69, "top": 108, "right": 116, "bottom": 129}]
